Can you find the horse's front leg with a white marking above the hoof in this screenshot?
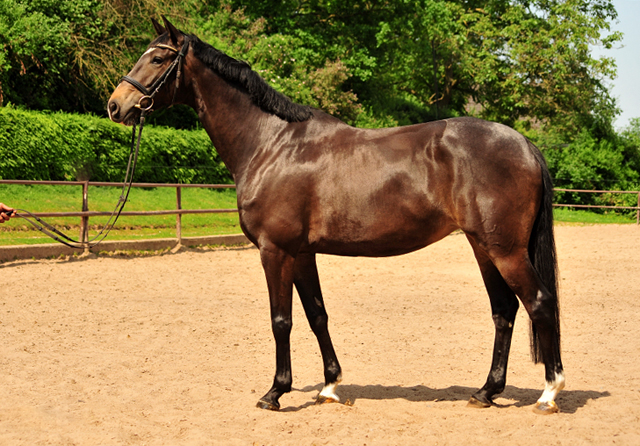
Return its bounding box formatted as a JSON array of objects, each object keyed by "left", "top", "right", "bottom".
[{"left": 293, "top": 254, "right": 342, "bottom": 403}]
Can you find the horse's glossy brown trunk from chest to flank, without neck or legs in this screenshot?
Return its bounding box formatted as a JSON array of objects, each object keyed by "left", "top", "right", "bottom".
[{"left": 240, "top": 115, "right": 544, "bottom": 256}]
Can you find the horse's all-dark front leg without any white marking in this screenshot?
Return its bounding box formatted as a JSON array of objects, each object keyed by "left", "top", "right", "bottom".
[{"left": 257, "top": 246, "right": 295, "bottom": 410}]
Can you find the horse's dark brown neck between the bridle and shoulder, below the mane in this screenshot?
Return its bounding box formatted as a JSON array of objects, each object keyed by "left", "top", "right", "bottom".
[{"left": 185, "top": 63, "right": 287, "bottom": 181}]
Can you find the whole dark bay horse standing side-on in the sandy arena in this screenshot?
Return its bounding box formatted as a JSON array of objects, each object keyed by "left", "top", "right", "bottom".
[{"left": 108, "top": 19, "right": 565, "bottom": 413}]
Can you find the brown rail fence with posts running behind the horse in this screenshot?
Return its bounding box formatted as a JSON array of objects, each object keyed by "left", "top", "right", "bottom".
[{"left": 0, "top": 180, "right": 640, "bottom": 243}]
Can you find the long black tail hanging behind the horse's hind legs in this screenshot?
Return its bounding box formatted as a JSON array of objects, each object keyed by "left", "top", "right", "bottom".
[{"left": 529, "top": 142, "right": 560, "bottom": 363}]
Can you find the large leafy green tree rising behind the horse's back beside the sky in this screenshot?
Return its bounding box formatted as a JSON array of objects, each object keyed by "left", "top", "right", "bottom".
[{"left": 225, "top": 0, "right": 621, "bottom": 135}]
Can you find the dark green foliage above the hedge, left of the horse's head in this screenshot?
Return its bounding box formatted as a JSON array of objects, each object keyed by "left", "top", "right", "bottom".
[{"left": 0, "top": 0, "right": 189, "bottom": 114}]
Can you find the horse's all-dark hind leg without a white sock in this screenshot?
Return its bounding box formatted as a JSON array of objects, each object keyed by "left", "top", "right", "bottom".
[{"left": 469, "top": 239, "right": 518, "bottom": 407}]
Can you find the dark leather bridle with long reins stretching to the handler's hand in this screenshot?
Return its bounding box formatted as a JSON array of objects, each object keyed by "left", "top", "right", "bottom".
[{"left": 10, "top": 40, "right": 189, "bottom": 249}]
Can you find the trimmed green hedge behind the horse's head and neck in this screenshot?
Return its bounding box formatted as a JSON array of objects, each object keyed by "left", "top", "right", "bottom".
[{"left": 0, "top": 106, "right": 232, "bottom": 184}]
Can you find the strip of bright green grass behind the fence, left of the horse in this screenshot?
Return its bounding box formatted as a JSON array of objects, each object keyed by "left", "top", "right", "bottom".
[{"left": 0, "top": 184, "right": 242, "bottom": 245}]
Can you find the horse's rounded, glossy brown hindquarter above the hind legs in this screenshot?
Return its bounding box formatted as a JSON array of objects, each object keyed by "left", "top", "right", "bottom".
[{"left": 443, "top": 118, "right": 542, "bottom": 255}]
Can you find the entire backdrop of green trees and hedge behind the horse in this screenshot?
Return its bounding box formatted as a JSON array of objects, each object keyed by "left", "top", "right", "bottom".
[{"left": 0, "top": 0, "right": 640, "bottom": 207}]
